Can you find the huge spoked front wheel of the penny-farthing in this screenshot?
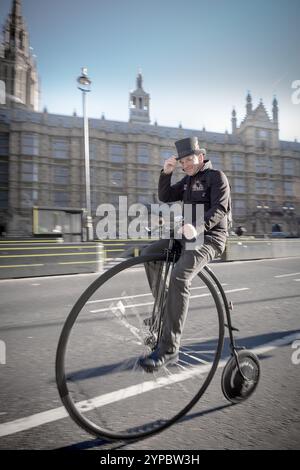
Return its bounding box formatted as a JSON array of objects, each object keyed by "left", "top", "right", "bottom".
[{"left": 56, "top": 256, "right": 224, "bottom": 439}]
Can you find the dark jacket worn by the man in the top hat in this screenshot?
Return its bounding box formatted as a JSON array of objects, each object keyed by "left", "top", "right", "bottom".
[{"left": 158, "top": 160, "right": 230, "bottom": 251}]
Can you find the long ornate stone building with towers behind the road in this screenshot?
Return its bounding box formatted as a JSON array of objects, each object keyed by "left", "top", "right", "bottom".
[{"left": 0, "top": 1, "right": 300, "bottom": 236}]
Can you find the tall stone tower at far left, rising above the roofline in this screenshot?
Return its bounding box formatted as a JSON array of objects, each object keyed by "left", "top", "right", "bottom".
[{"left": 0, "top": 0, "right": 39, "bottom": 111}]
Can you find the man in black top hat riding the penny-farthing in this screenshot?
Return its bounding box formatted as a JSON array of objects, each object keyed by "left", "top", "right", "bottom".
[{"left": 139, "top": 137, "right": 230, "bottom": 372}]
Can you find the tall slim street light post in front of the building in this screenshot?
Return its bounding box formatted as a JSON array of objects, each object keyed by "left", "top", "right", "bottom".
[{"left": 77, "top": 67, "right": 94, "bottom": 241}]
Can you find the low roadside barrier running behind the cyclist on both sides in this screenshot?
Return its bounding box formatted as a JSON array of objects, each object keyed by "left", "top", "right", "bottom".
[{"left": 0, "top": 237, "right": 300, "bottom": 279}]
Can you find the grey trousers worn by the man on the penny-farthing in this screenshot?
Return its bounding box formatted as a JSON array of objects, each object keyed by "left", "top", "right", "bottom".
[{"left": 141, "top": 240, "right": 220, "bottom": 352}]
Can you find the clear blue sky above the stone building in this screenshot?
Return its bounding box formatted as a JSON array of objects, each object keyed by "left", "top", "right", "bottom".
[{"left": 0, "top": 0, "right": 300, "bottom": 141}]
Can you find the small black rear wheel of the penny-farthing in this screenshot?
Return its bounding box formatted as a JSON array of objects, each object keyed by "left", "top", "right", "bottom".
[{"left": 221, "top": 350, "right": 260, "bottom": 403}]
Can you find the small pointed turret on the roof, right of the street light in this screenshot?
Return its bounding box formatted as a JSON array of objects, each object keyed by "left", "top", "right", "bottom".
[{"left": 129, "top": 72, "right": 150, "bottom": 124}]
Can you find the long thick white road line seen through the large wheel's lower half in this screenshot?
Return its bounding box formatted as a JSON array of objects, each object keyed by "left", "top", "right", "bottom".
[{"left": 0, "top": 331, "right": 300, "bottom": 437}]
